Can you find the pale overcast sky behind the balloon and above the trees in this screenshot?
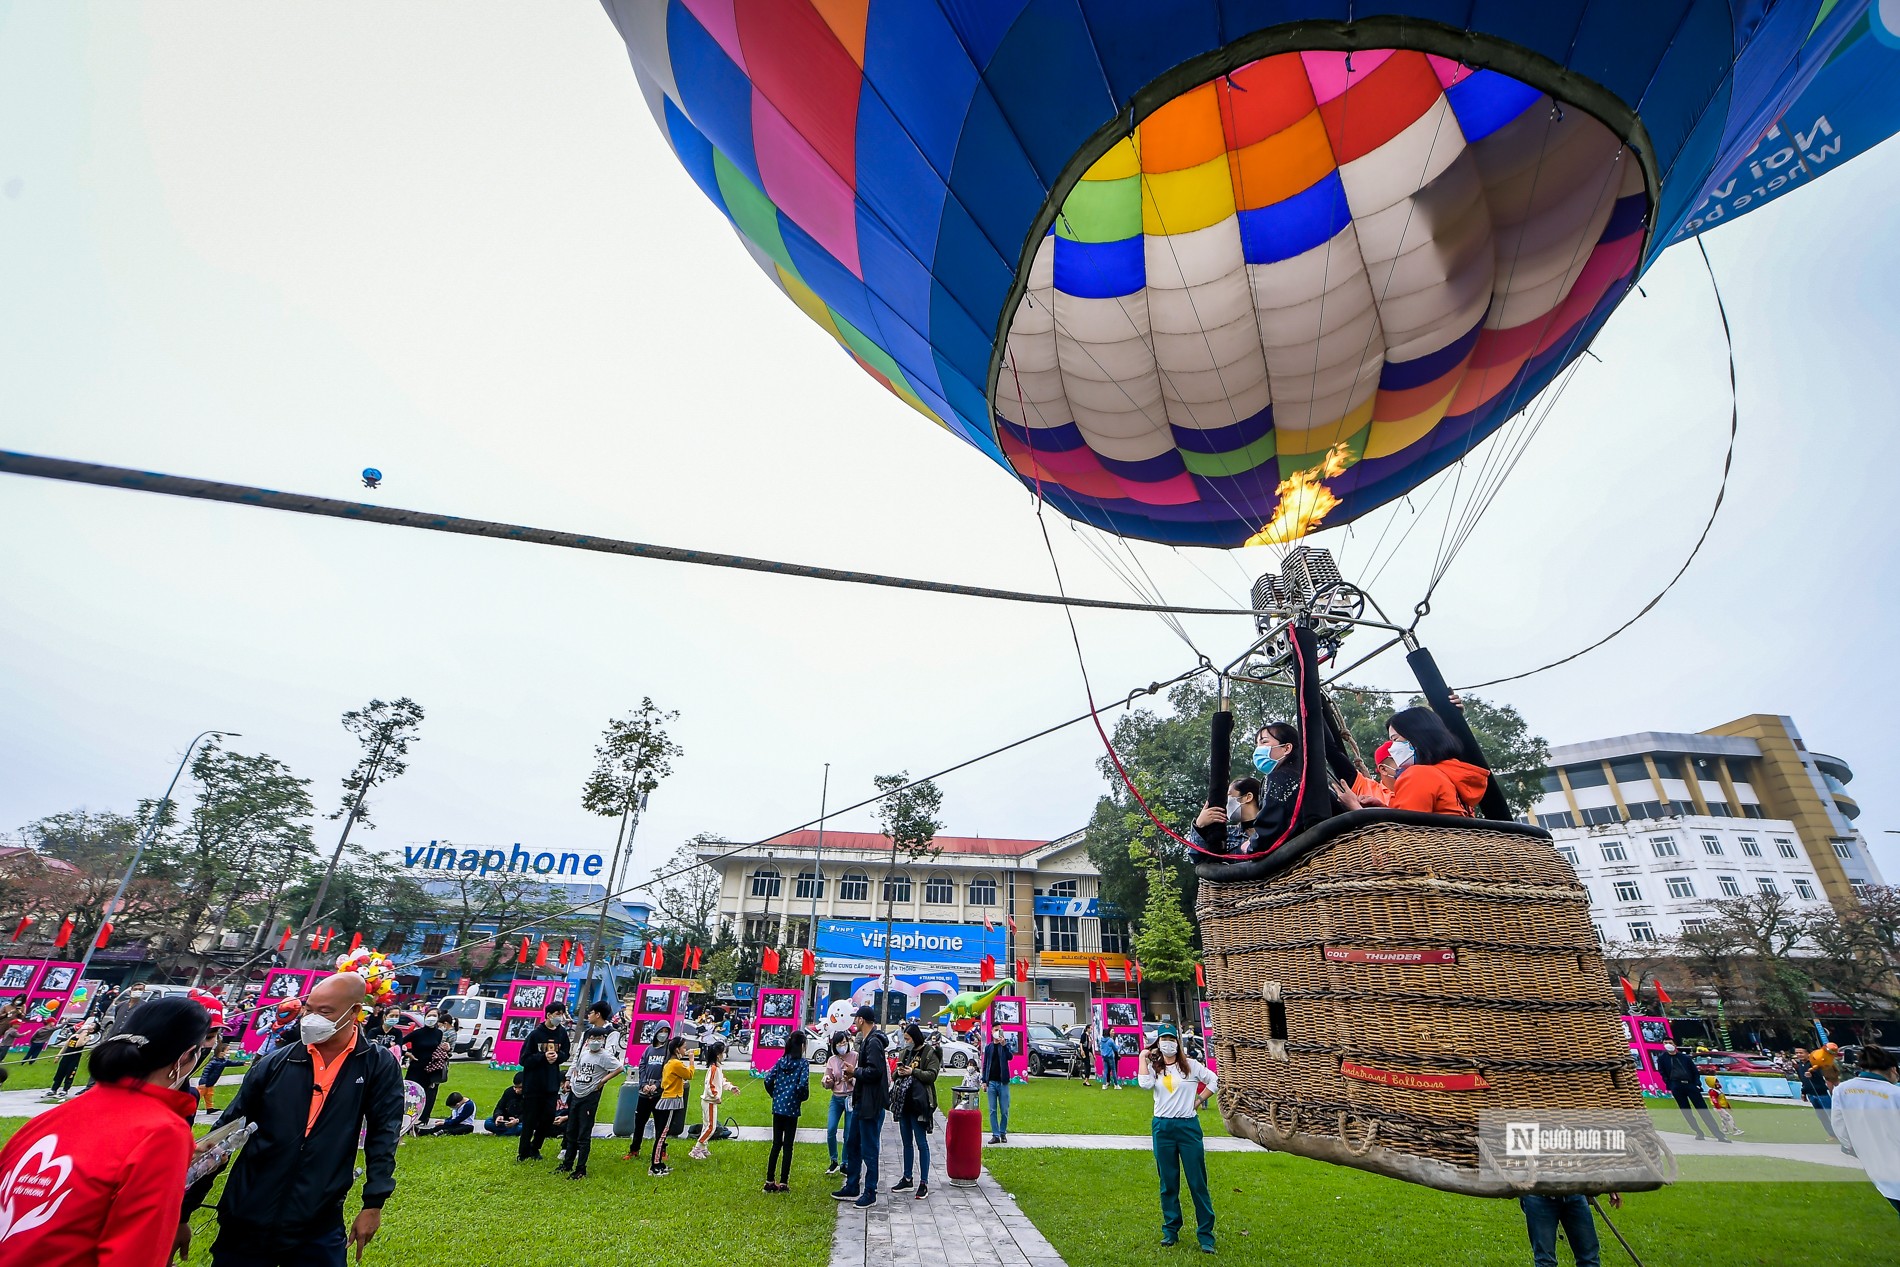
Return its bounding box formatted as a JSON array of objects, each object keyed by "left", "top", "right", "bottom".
[{"left": 0, "top": 0, "right": 1900, "bottom": 879}]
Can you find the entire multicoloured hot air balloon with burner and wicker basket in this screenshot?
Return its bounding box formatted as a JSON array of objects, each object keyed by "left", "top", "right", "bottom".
[{"left": 604, "top": 0, "right": 1900, "bottom": 1197}]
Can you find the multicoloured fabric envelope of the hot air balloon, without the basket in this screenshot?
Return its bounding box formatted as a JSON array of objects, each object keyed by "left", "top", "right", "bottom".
[{"left": 606, "top": 0, "right": 1900, "bottom": 545}]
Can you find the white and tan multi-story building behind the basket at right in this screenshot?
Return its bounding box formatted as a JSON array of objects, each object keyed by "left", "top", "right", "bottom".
[{"left": 1530, "top": 714, "right": 1881, "bottom": 942}]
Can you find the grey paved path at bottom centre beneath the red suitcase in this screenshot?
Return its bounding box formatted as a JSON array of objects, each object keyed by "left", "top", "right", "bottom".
[{"left": 832, "top": 1117, "right": 1066, "bottom": 1267}]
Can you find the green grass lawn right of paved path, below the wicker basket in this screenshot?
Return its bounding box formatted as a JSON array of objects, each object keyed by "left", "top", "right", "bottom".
[{"left": 984, "top": 1149, "right": 1896, "bottom": 1267}]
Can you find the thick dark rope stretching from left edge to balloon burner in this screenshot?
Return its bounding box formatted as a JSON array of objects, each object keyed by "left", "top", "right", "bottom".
[{"left": 0, "top": 450, "right": 1252, "bottom": 615}]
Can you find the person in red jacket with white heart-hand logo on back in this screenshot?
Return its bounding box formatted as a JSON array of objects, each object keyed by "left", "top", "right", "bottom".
[{"left": 0, "top": 997, "right": 211, "bottom": 1267}]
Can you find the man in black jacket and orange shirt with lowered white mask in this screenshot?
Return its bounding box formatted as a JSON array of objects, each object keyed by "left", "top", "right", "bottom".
[{"left": 184, "top": 973, "right": 403, "bottom": 1267}]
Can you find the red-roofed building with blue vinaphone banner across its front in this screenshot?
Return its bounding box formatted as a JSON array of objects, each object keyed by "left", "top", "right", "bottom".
[{"left": 699, "top": 830, "right": 1129, "bottom": 1016}]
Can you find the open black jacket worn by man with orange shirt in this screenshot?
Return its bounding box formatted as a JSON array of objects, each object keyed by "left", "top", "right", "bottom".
[{"left": 184, "top": 1031, "right": 403, "bottom": 1246}]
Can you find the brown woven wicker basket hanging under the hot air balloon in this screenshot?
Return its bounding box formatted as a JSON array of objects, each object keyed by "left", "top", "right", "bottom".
[{"left": 1197, "top": 809, "right": 1674, "bottom": 1197}]
